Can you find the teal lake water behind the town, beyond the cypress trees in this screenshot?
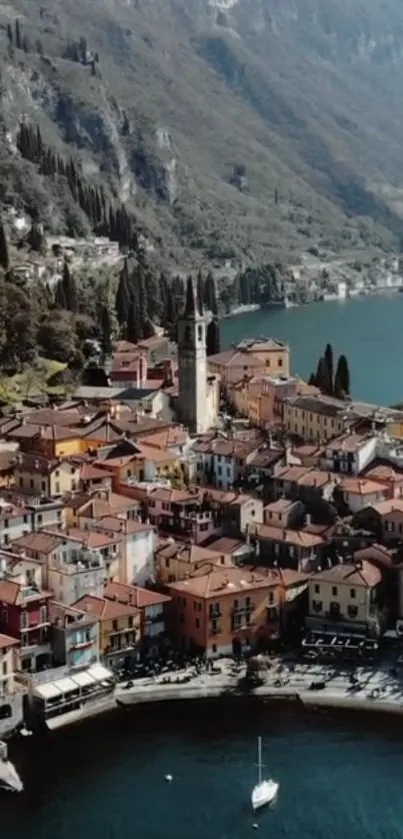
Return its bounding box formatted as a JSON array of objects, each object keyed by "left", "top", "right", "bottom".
[{"left": 221, "top": 294, "right": 403, "bottom": 405}]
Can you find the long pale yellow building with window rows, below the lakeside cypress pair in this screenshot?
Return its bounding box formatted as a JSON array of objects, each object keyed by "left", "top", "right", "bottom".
[{"left": 284, "top": 396, "right": 350, "bottom": 443}]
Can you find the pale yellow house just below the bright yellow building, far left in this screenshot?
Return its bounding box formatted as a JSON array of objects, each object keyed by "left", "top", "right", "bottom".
[{"left": 15, "top": 452, "right": 80, "bottom": 498}]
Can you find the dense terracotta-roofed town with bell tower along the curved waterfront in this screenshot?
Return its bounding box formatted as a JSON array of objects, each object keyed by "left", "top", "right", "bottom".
[{"left": 0, "top": 278, "right": 403, "bottom": 760}]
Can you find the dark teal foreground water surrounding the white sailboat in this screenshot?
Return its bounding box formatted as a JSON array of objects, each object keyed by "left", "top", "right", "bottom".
[{"left": 0, "top": 702, "right": 403, "bottom": 839}]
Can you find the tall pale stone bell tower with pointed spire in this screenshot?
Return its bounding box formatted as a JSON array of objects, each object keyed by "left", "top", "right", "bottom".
[{"left": 178, "top": 277, "right": 209, "bottom": 434}]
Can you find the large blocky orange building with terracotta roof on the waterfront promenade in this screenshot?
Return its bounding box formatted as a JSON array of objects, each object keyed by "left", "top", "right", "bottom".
[{"left": 167, "top": 566, "right": 285, "bottom": 656}]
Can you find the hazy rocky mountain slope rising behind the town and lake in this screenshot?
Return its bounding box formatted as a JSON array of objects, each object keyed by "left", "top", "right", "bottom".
[{"left": 0, "top": 0, "right": 403, "bottom": 267}]
